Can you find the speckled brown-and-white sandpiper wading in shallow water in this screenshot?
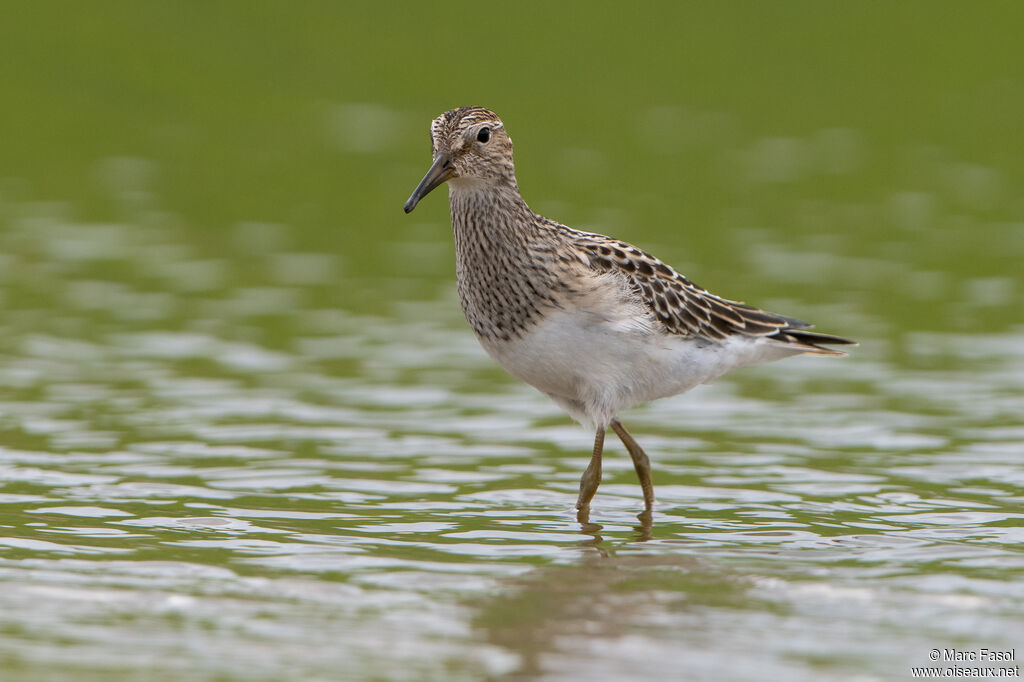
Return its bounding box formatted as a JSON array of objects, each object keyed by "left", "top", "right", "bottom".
[{"left": 404, "top": 106, "right": 856, "bottom": 518}]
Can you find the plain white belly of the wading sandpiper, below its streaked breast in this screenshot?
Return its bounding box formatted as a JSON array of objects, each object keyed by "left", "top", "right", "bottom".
[{"left": 481, "top": 306, "right": 797, "bottom": 427}]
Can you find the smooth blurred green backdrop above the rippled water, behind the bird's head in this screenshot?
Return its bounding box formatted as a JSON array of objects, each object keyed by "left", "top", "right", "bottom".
[{"left": 0, "top": 1, "right": 1024, "bottom": 337}]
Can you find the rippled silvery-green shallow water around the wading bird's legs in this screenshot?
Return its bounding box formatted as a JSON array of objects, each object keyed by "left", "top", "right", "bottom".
[{"left": 0, "top": 207, "right": 1024, "bottom": 680}]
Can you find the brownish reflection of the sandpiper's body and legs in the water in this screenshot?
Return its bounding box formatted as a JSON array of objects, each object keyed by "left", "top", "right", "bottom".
[{"left": 474, "top": 516, "right": 720, "bottom": 682}]
